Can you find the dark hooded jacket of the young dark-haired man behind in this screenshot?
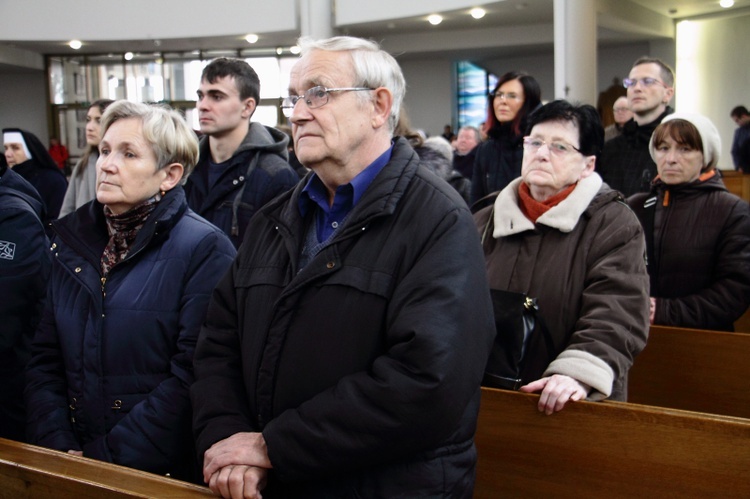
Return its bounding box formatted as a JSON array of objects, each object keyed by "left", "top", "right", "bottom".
[{"left": 185, "top": 123, "right": 299, "bottom": 248}]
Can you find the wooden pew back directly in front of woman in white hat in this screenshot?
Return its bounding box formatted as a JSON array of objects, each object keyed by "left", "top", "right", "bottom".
[{"left": 628, "top": 326, "right": 750, "bottom": 420}]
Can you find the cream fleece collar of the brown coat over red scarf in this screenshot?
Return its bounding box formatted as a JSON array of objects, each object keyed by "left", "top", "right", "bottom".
[{"left": 492, "top": 172, "right": 602, "bottom": 239}]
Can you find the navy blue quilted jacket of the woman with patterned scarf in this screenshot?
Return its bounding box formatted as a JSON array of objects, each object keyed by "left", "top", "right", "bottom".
[{"left": 26, "top": 187, "right": 235, "bottom": 479}]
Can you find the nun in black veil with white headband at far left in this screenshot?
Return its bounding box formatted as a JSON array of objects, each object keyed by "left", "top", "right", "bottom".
[{"left": 3, "top": 128, "right": 68, "bottom": 222}]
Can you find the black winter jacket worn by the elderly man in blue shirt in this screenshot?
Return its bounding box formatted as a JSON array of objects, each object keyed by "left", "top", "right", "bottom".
[{"left": 191, "top": 139, "right": 495, "bottom": 498}]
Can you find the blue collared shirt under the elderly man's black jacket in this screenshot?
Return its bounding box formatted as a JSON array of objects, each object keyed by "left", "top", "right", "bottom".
[{"left": 297, "top": 144, "right": 393, "bottom": 243}]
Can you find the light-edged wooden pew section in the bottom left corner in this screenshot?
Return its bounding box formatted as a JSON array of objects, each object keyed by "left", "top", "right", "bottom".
[{"left": 0, "top": 438, "right": 215, "bottom": 499}]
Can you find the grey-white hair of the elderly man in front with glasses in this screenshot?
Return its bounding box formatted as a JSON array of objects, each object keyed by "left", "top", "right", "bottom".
[{"left": 297, "top": 36, "right": 406, "bottom": 133}]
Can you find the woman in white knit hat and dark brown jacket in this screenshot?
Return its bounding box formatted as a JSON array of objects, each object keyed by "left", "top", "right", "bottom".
[{"left": 628, "top": 113, "right": 750, "bottom": 331}]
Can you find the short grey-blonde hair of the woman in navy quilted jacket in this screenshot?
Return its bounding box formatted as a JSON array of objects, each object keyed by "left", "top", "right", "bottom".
[{"left": 101, "top": 100, "right": 199, "bottom": 184}]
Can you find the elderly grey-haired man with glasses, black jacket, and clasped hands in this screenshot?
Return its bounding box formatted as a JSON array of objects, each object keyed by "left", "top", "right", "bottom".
[{"left": 192, "top": 37, "right": 494, "bottom": 498}]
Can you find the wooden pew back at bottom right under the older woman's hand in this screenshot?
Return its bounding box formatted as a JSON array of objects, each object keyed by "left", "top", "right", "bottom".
[{"left": 474, "top": 388, "right": 750, "bottom": 499}]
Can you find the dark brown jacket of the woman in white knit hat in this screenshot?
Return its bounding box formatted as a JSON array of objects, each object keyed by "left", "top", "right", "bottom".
[{"left": 628, "top": 173, "right": 750, "bottom": 331}]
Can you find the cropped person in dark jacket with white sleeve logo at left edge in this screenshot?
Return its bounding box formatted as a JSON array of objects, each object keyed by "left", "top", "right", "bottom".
[{"left": 0, "top": 158, "right": 51, "bottom": 441}]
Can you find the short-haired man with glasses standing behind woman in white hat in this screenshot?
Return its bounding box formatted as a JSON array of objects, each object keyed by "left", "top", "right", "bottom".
[{"left": 596, "top": 57, "right": 674, "bottom": 197}]
